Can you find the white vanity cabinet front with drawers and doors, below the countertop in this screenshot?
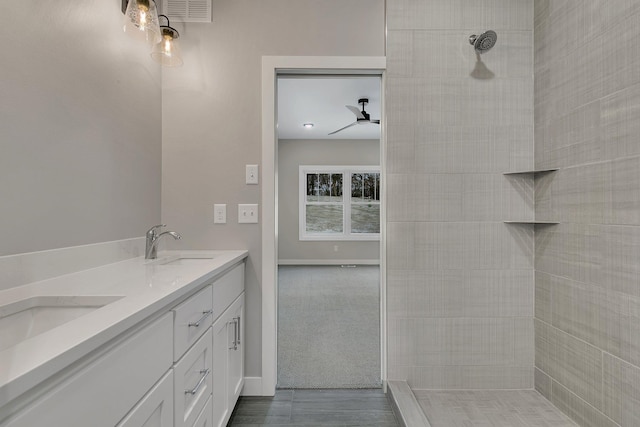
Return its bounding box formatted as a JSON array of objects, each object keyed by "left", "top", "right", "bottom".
[{"left": 0, "top": 261, "right": 244, "bottom": 427}]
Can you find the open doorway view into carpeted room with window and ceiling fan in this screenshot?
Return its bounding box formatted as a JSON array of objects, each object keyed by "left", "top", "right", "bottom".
[{"left": 276, "top": 74, "right": 382, "bottom": 389}]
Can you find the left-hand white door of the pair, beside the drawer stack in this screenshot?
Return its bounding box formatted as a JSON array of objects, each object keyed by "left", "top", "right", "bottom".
[{"left": 211, "top": 312, "right": 230, "bottom": 427}]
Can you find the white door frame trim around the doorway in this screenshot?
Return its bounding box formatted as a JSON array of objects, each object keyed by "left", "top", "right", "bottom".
[{"left": 258, "top": 56, "right": 387, "bottom": 396}]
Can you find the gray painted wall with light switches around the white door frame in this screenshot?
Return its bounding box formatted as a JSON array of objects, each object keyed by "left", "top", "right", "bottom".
[{"left": 162, "top": 0, "right": 384, "bottom": 382}]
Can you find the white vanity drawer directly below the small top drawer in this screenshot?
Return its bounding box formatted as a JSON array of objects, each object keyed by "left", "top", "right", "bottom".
[{"left": 173, "top": 328, "right": 213, "bottom": 427}]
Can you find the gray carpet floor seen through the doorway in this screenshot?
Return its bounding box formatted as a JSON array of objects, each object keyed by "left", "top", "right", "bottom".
[{"left": 277, "top": 266, "right": 381, "bottom": 389}]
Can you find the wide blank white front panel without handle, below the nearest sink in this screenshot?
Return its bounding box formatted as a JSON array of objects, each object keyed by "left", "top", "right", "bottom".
[{"left": 2, "top": 313, "right": 173, "bottom": 427}]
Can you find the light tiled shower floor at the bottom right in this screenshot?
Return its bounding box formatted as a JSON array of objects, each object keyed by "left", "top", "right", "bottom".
[{"left": 413, "top": 390, "right": 577, "bottom": 427}]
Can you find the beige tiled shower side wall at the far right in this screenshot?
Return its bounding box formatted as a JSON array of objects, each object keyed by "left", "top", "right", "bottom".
[{"left": 535, "top": 0, "right": 640, "bottom": 427}]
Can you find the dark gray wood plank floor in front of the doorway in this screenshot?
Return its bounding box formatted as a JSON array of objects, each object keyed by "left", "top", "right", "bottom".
[{"left": 228, "top": 389, "right": 399, "bottom": 427}]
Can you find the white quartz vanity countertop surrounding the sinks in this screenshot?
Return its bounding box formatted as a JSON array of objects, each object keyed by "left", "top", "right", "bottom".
[{"left": 0, "top": 250, "right": 248, "bottom": 407}]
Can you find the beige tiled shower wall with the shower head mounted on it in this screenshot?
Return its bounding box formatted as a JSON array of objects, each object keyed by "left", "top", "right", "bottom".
[{"left": 386, "top": 0, "right": 534, "bottom": 389}]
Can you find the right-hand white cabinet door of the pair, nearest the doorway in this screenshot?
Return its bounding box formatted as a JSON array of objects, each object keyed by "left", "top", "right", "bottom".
[{"left": 228, "top": 292, "right": 245, "bottom": 411}]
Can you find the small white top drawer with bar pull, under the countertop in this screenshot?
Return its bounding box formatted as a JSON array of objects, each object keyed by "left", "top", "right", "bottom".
[{"left": 173, "top": 285, "right": 214, "bottom": 361}]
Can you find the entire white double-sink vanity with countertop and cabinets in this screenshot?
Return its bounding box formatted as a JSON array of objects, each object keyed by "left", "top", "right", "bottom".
[{"left": 0, "top": 251, "right": 247, "bottom": 427}]
